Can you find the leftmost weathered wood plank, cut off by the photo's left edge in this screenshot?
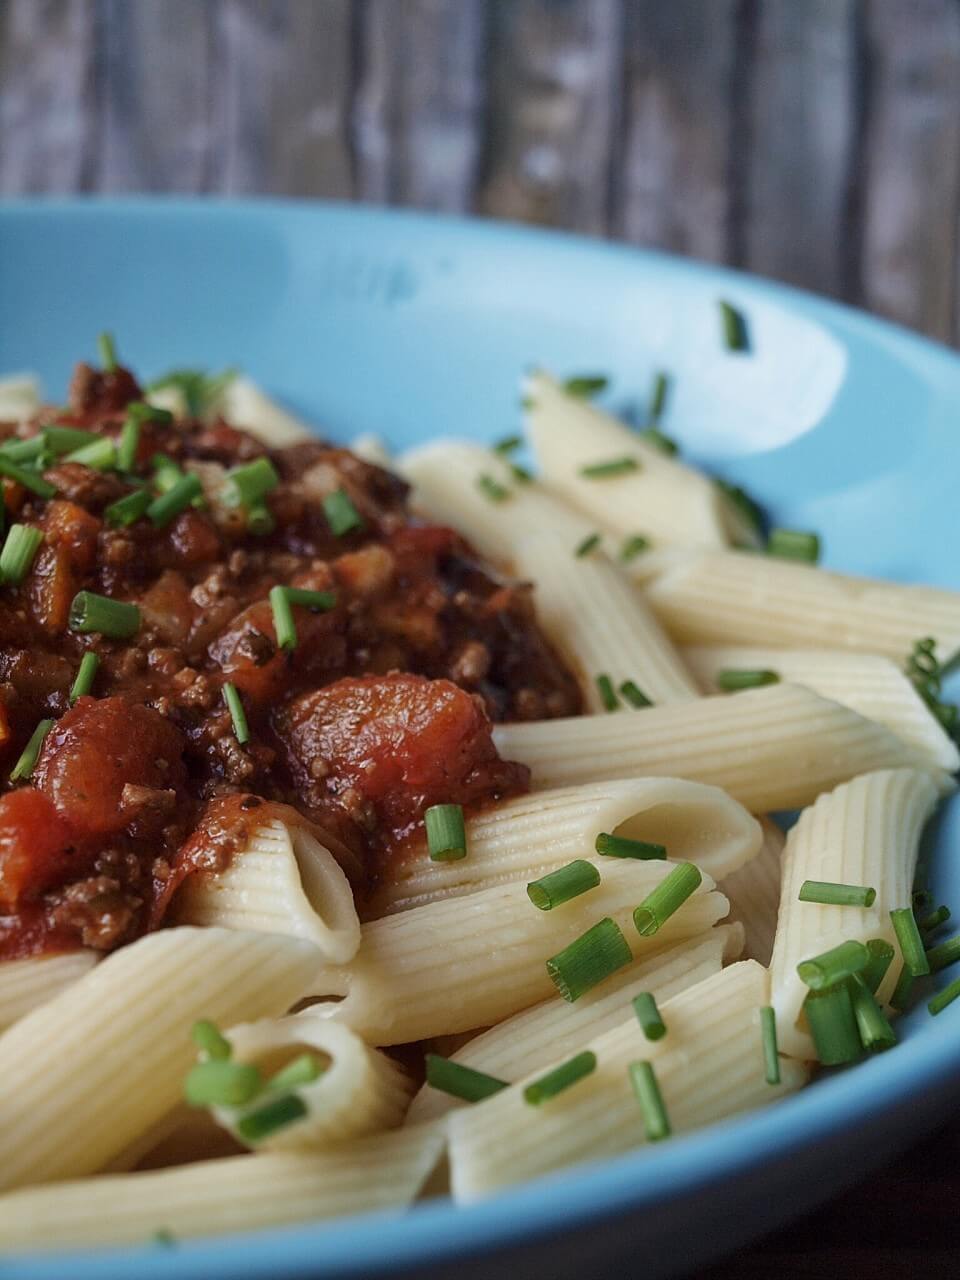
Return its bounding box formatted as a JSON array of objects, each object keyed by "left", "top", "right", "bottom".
[{"left": 0, "top": 0, "right": 97, "bottom": 196}]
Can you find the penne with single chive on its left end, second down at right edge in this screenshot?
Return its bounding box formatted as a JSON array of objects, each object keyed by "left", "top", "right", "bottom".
[{"left": 684, "top": 645, "right": 960, "bottom": 773}]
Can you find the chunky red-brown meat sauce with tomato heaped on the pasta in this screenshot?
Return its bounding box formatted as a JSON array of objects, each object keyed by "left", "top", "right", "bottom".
[{"left": 0, "top": 365, "right": 581, "bottom": 959}]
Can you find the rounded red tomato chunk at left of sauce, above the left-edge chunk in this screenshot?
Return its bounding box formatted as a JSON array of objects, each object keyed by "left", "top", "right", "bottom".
[{"left": 33, "top": 698, "right": 186, "bottom": 835}]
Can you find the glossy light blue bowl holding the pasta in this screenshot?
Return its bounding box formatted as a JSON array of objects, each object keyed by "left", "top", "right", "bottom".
[{"left": 0, "top": 200, "right": 960, "bottom": 1280}]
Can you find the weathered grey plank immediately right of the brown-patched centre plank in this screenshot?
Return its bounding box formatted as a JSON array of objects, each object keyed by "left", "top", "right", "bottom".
[{"left": 613, "top": 0, "right": 737, "bottom": 261}]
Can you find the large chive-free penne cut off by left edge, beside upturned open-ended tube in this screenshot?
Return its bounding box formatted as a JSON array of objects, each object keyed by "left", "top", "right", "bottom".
[{"left": 0, "top": 928, "right": 320, "bottom": 1188}]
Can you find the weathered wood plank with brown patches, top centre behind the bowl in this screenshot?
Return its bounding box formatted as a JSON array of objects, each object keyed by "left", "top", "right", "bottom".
[{"left": 479, "top": 0, "right": 622, "bottom": 233}]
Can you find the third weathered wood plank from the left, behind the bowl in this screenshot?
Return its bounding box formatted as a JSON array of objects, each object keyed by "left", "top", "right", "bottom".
[{"left": 215, "top": 0, "right": 353, "bottom": 197}]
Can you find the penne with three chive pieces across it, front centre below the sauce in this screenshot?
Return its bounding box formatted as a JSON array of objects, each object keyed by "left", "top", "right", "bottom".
[{"left": 312, "top": 858, "right": 727, "bottom": 1044}]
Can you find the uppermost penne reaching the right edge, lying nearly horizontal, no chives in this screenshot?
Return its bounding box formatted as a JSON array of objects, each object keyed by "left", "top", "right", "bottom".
[{"left": 646, "top": 552, "right": 960, "bottom": 663}]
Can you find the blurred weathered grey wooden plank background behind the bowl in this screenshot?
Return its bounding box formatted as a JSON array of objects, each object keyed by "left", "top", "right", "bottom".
[{"left": 0, "top": 0, "right": 960, "bottom": 342}]
